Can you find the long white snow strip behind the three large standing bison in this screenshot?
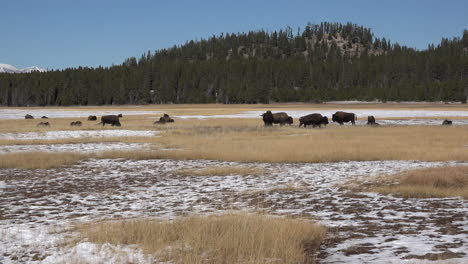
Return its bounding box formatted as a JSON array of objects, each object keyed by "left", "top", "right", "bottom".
[{"left": 176, "top": 107, "right": 468, "bottom": 120}]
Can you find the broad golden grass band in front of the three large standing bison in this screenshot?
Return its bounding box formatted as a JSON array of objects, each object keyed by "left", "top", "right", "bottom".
[{"left": 149, "top": 125, "right": 468, "bottom": 162}]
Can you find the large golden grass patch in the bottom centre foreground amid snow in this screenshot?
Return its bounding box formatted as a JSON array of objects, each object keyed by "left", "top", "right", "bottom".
[{"left": 79, "top": 213, "right": 326, "bottom": 263}]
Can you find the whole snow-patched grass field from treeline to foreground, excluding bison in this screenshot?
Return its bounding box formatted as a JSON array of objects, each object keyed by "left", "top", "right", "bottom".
[{"left": 0, "top": 104, "right": 468, "bottom": 263}]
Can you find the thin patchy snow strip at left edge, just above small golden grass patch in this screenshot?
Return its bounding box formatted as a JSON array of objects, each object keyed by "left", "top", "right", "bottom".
[{"left": 0, "top": 142, "right": 151, "bottom": 154}]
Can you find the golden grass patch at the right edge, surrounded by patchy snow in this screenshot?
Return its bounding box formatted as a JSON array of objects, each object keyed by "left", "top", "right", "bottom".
[{"left": 356, "top": 166, "right": 468, "bottom": 199}]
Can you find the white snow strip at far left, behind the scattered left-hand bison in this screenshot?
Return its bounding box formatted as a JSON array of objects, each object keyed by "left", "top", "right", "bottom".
[{"left": 0, "top": 109, "right": 162, "bottom": 120}]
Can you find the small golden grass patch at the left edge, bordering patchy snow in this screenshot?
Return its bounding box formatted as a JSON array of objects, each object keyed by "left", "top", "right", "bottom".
[{"left": 0, "top": 152, "right": 85, "bottom": 169}]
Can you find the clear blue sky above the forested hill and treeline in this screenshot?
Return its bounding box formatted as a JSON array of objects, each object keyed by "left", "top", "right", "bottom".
[{"left": 0, "top": 0, "right": 468, "bottom": 69}]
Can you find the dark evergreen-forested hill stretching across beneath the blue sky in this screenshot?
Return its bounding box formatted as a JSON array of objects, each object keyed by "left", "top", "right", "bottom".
[{"left": 0, "top": 23, "right": 468, "bottom": 106}]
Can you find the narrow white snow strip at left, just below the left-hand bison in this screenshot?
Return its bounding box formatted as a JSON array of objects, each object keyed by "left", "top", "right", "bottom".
[{"left": 0, "top": 129, "right": 159, "bottom": 140}]
